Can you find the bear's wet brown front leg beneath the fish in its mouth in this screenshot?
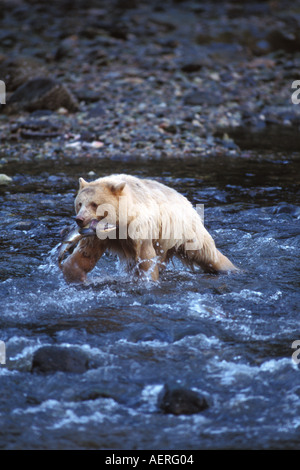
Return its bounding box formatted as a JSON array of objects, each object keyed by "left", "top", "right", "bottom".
[{"left": 61, "top": 238, "right": 105, "bottom": 283}]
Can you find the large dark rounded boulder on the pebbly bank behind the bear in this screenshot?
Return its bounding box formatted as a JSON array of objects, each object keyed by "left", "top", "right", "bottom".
[{"left": 7, "top": 77, "right": 78, "bottom": 113}]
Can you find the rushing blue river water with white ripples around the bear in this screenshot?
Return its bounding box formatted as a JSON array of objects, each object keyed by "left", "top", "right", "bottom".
[{"left": 0, "top": 155, "right": 300, "bottom": 449}]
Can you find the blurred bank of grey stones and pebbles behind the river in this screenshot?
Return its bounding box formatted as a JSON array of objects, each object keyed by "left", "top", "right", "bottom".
[{"left": 0, "top": 0, "right": 300, "bottom": 169}]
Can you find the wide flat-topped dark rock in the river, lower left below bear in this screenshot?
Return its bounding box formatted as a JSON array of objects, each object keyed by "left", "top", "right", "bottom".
[{"left": 31, "top": 346, "right": 89, "bottom": 374}]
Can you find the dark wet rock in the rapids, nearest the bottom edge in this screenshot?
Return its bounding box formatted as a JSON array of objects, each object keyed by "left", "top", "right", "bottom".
[{"left": 158, "top": 385, "right": 208, "bottom": 415}]
